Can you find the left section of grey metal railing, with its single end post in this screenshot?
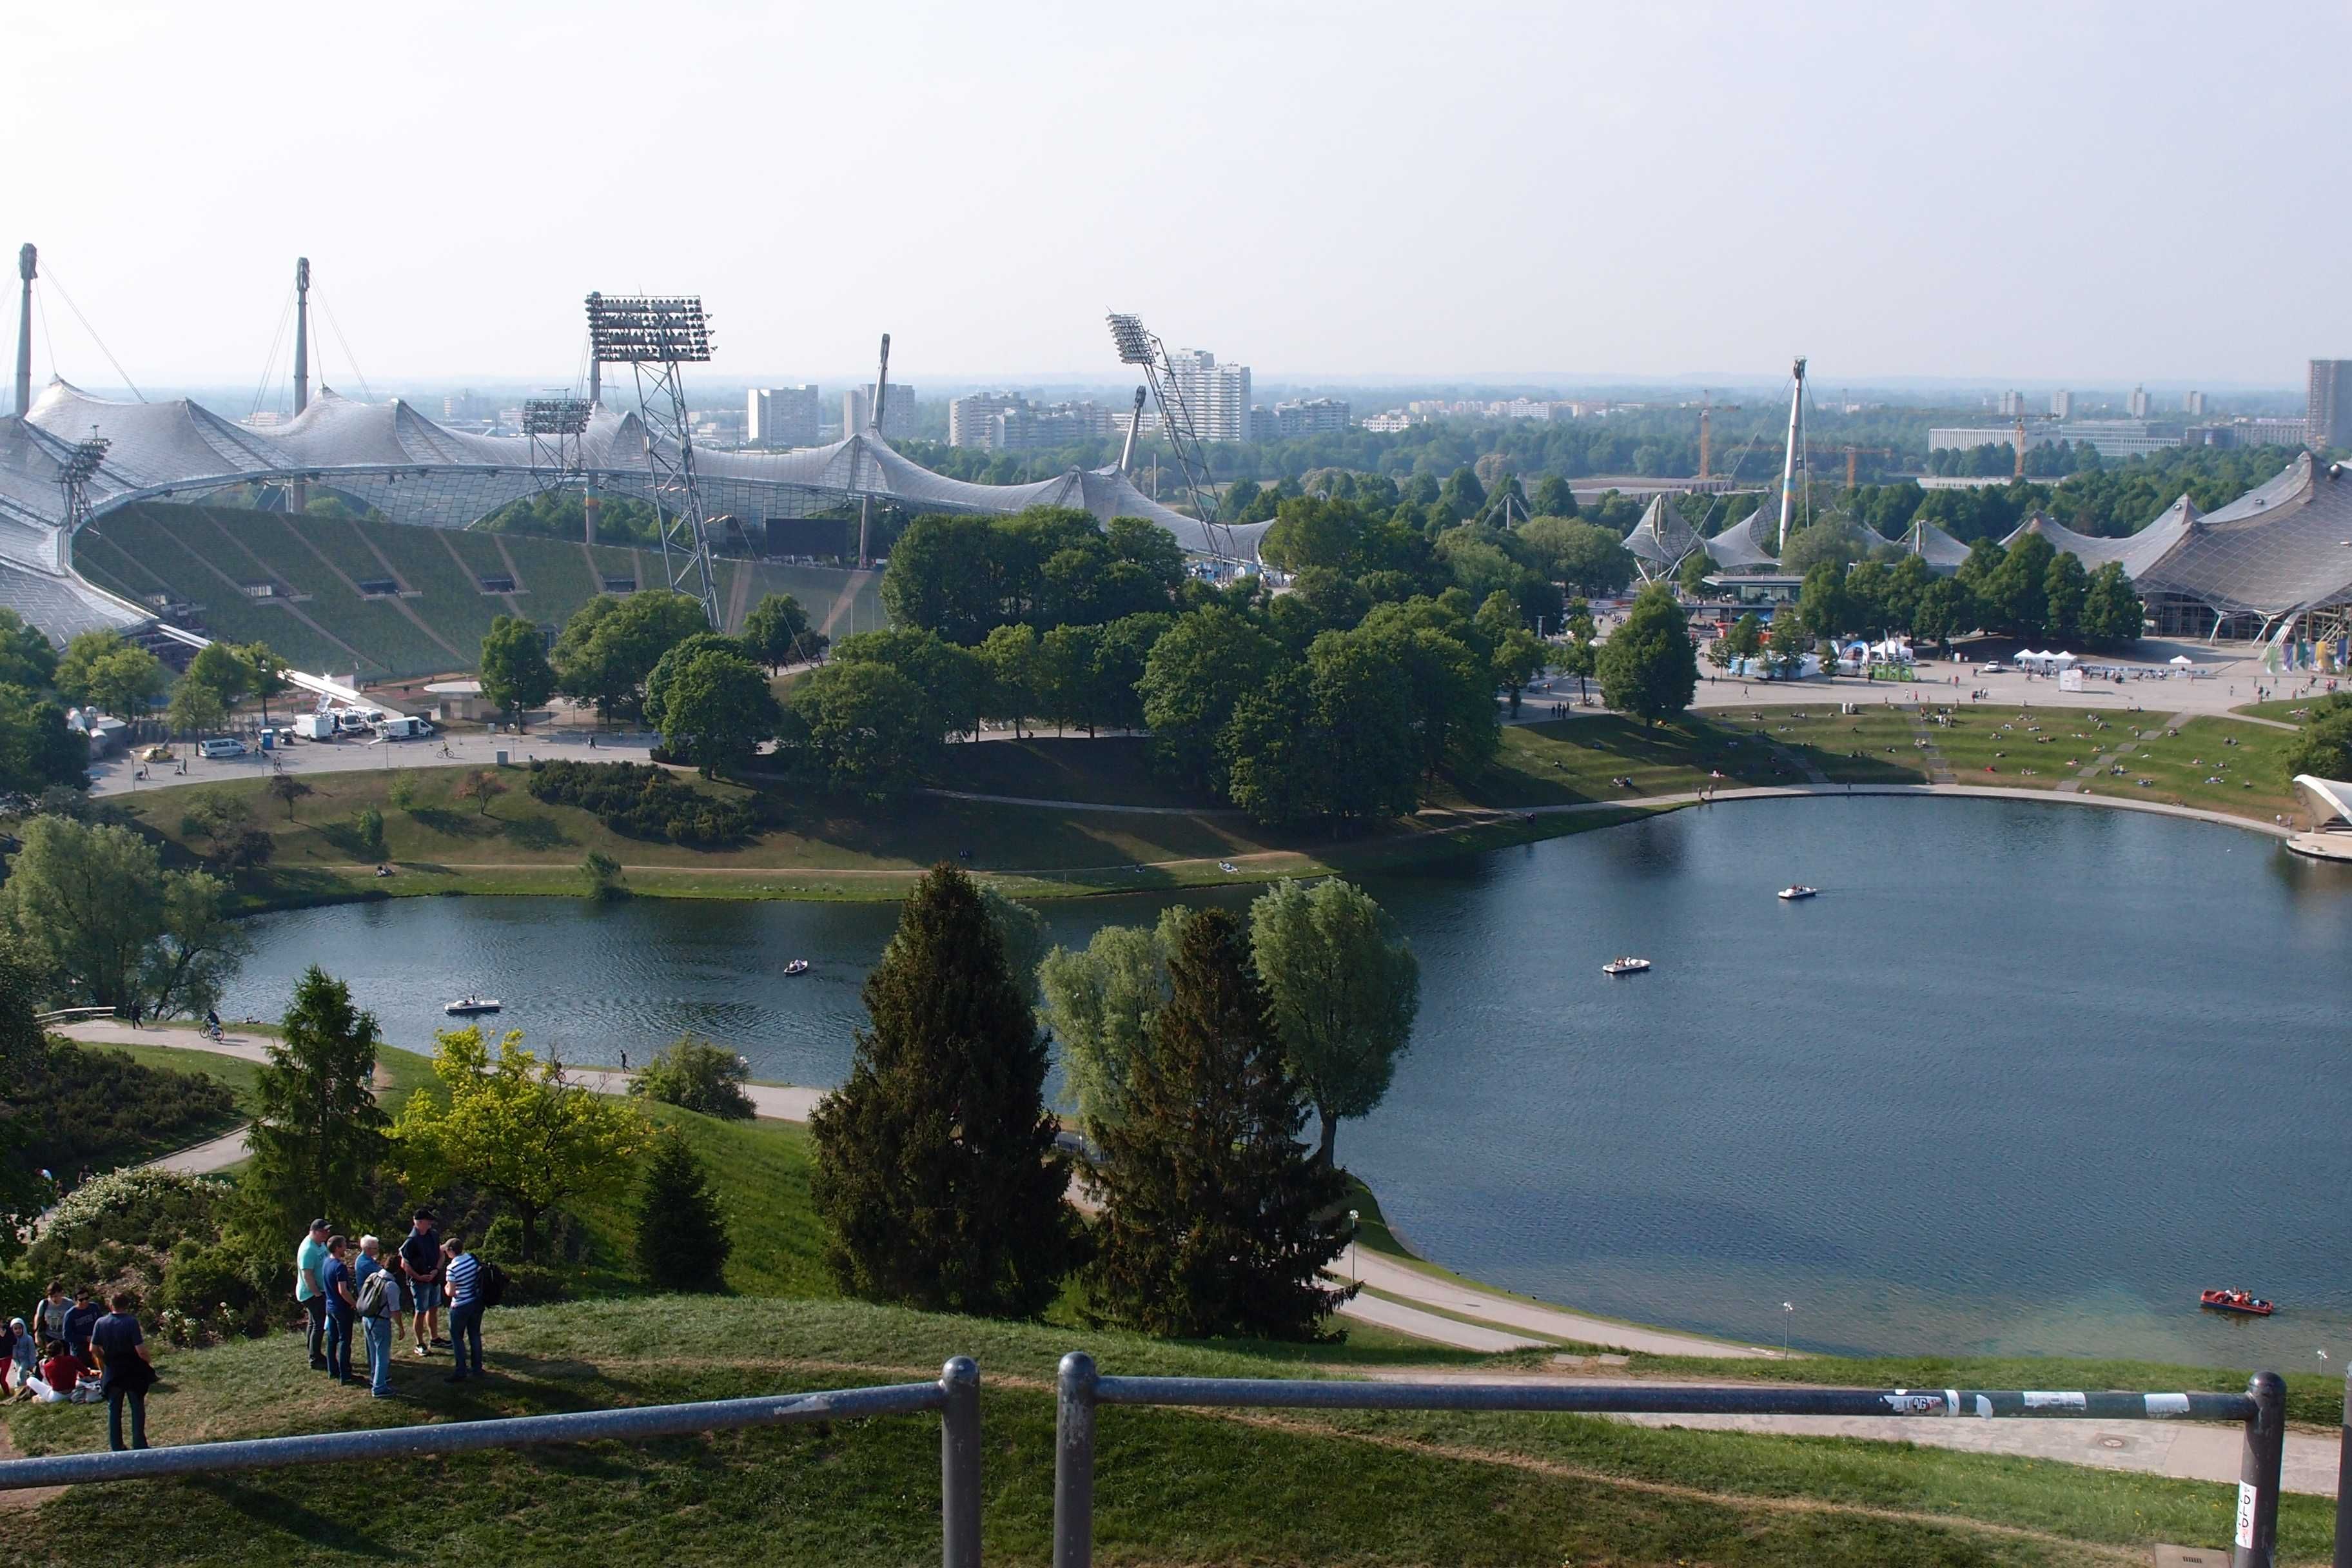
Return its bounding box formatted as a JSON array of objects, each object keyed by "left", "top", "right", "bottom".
[{"left": 0, "top": 1357, "right": 981, "bottom": 1568}]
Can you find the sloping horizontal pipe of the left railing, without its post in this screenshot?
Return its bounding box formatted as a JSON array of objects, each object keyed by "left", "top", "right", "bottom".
[{"left": 0, "top": 1382, "right": 948, "bottom": 1491}]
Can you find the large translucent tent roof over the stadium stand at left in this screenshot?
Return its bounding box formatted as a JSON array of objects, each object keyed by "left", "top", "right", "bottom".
[{"left": 0, "top": 381, "right": 1273, "bottom": 640}]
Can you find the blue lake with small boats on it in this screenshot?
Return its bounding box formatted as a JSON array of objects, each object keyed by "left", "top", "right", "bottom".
[{"left": 224, "top": 797, "right": 2352, "bottom": 1366}]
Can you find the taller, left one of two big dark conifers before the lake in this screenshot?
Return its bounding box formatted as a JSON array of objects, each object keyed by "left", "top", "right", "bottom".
[{"left": 809, "top": 865, "right": 1084, "bottom": 1317}]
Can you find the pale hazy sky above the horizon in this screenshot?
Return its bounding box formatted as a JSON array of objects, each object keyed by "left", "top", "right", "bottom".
[{"left": 0, "top": 0, "right": 2352, "bottom": 386}]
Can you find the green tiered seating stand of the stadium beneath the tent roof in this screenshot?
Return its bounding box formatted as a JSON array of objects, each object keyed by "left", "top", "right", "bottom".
[{"left": 73, "top": 501, "right": 879, "bottom": 680}]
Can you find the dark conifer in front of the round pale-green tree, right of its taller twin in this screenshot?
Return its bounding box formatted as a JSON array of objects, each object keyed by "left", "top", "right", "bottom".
[{"left": 1089, "top": 910, "right": 1355, "bottom": 1340}]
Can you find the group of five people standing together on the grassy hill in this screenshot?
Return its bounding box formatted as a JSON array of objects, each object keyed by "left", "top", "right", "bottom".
[{"left": 294, "top": 1208, "right": 487, "bottom": 1398}]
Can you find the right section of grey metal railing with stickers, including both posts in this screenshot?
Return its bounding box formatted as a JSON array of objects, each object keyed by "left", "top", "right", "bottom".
[{"left": 1054, "top": 1352, "right": 2286, "bottom": 1568}]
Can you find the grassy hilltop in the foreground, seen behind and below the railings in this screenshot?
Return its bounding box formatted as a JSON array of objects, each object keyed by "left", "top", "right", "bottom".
[{"left": 0, "top": 1298, "right": 2331, "bottom": 1568}]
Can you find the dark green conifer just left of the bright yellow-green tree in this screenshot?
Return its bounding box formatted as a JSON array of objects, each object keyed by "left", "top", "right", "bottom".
[{"left": 244, "top": 964, "right": 391, "bottom": 1237}]
